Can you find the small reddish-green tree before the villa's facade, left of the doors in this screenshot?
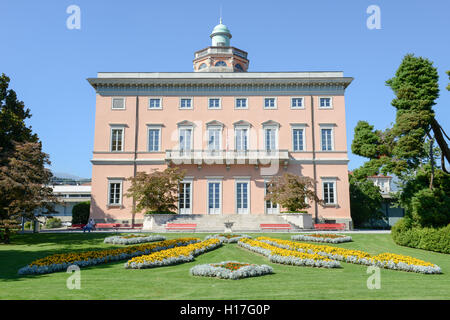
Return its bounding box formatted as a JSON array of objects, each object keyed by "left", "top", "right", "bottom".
[{"left": 125, "top": 167, "right": 185, "bottom": 213}]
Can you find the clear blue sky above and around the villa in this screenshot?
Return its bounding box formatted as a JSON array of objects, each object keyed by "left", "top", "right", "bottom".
[{"left": 0, "top": 0, "right": 450, "bottom": 178}]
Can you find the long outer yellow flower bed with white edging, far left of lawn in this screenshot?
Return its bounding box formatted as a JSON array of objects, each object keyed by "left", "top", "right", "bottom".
[{"left": 18, "top": 238, "right": 200, "bottom": 275}]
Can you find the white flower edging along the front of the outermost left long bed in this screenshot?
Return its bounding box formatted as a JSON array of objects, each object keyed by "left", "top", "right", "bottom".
[{"left": 17, "top": 240, "right": 199, "bottom": 275}]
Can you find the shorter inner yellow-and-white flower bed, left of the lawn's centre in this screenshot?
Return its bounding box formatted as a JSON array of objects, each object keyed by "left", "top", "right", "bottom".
[{"left": 124, "top": 239, "right": 222, "bottom": 269}]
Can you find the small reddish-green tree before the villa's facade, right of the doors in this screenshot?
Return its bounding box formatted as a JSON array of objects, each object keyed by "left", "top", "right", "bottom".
[{"left": 265, "top": 173, "right": 323, "bottom": 212}]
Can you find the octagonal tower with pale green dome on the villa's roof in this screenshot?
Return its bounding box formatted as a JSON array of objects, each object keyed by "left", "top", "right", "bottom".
[{"left": 193, "top": 17, "right": 249, "bottom": 72}]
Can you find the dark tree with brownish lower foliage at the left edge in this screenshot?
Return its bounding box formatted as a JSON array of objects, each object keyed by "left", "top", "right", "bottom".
[{"left": 0, "top": 74, "right": 57, "bottom": 243}]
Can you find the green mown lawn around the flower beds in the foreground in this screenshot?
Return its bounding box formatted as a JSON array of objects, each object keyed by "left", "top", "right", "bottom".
[{"left": 0, "top": 233, "right": 450, "bottom": 300}]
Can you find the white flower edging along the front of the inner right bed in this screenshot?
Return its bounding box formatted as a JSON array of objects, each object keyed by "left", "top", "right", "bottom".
[{"left": 238, "top": 242, "right": 341, "bottom": 268}]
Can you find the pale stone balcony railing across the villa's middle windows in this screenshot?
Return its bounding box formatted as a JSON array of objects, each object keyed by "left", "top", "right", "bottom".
[{"left": 166, "top": 149, "right": 289, "bottom": 165}]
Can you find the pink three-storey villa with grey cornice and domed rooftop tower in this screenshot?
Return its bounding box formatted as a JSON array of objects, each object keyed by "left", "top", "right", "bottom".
[{"left": 88, "top": 23, "right": 353, "bottom": 229}]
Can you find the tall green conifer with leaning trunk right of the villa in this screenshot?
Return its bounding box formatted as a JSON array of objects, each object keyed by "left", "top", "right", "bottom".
[{"left": 352, "top": 54, "right": 450, "bottom": 230}]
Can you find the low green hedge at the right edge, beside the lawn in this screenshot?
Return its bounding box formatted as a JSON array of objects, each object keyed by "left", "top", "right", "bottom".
[{"left": 391, "top": 218, "right": 450, "bottom": 253}]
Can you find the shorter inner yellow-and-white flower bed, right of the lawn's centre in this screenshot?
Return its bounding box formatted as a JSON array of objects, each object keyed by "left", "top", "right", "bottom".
[{"left": 238, "top": 239, "right": 341, "bottom": 268}]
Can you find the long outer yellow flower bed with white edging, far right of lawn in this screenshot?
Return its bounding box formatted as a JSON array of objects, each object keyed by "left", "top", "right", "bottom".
[{"left": 256, "top": 237, "right": 442, "bottom": 274}]
